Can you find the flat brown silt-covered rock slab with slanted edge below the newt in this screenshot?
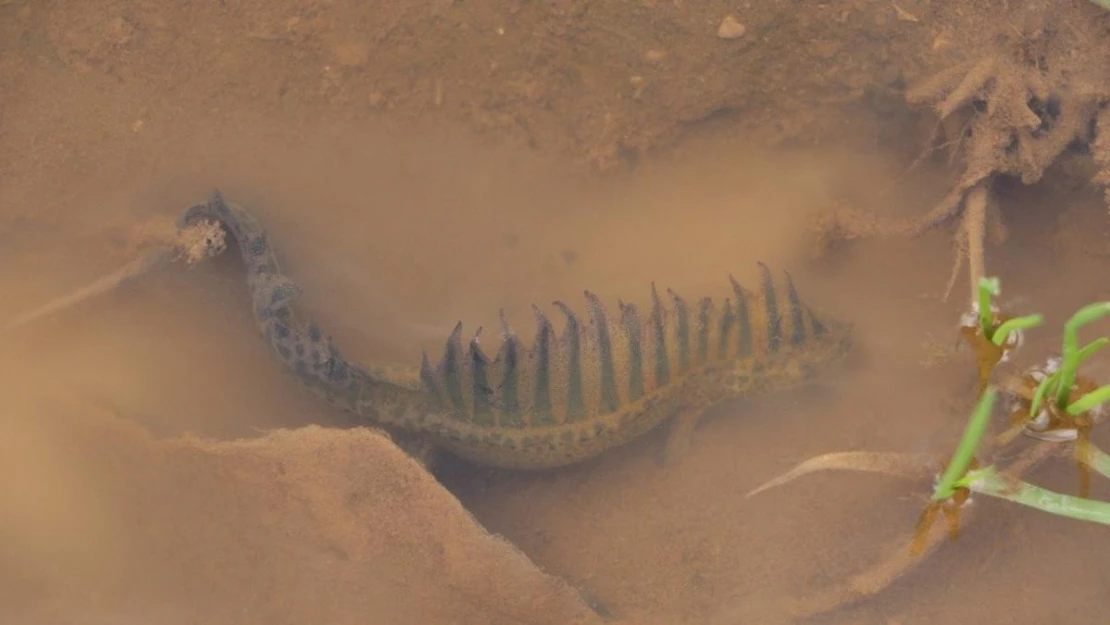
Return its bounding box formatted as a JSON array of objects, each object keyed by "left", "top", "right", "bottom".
[{"left": 0, "top": 394, "right": 603, "bottom": 625}]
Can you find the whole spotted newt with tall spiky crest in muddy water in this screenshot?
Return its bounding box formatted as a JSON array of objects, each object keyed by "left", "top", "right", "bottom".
[{"left": 180, "top": 192, "right": 852, "bottom": 470}]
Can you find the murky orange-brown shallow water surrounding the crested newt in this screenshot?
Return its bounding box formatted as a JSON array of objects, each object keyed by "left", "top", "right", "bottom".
[{"left": 0, "top": 112, "right": 1110, "bottom": 624}]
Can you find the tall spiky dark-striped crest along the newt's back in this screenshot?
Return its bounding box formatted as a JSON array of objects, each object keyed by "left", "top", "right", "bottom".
[{"left": 421, "top": 263, "right": 825, "bottom": 427}]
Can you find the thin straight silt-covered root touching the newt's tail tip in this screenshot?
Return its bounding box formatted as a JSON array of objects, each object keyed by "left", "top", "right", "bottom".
[{"left": 0, "top": 223, "right": 225, "bottom": 334}]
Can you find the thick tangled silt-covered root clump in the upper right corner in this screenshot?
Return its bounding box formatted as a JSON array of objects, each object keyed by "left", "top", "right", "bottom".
[{"left": 819, "top": 6, "right": 1110, "bottom": 301}]
